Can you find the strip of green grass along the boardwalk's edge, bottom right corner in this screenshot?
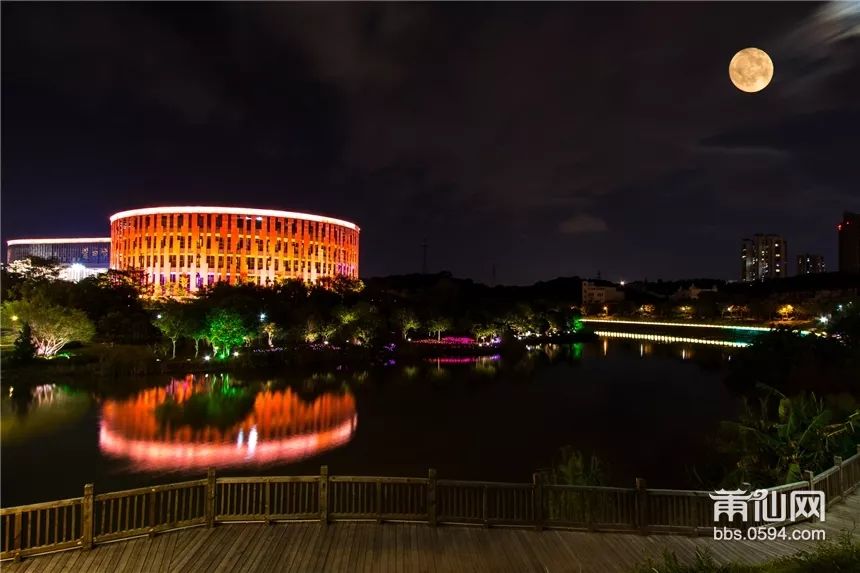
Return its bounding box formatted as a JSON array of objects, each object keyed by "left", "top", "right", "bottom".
[{"left": 631, "top": 531, "right": 860, "bottom": 573}]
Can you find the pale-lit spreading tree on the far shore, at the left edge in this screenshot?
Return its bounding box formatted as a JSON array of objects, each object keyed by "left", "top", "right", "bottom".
[{"left": 3, "top": 299, "right": 95, "bottom": 357}]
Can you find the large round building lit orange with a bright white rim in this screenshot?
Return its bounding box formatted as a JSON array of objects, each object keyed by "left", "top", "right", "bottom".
[{"left": 110, "top": 207, "right": 360, "bottom": 292}]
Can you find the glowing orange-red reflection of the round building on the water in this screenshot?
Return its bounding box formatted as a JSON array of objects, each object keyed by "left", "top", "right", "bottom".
[{"left": 99, "top": 376, "right": 358, "bottom": 470}]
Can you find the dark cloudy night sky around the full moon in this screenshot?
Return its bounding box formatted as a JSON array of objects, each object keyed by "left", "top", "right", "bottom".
[{"left": 2, "top": 2, "right": 860, "bottom": 284}]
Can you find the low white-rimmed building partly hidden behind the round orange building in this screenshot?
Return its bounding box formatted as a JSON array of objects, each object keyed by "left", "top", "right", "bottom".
[{"left": 6, "top": 237, "right": 110, "bottom": 281}]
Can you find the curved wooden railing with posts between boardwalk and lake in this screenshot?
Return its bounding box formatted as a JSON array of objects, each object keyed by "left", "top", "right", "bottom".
[{"left": 0, "top": 446, "right": 860, "bottom": 559}]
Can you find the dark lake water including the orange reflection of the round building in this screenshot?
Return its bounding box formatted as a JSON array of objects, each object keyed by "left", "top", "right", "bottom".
[{"left": 0, "top": 339, "right": 738, "bottom": 507}]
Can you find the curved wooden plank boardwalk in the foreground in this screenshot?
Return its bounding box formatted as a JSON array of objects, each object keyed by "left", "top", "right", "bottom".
[{"left": 0, "top": 492, "right": 860, "bottom": 573}]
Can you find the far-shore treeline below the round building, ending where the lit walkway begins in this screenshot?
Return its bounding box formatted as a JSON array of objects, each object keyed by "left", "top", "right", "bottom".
[{"left": 2, "top": 262, "right": 579, "bottom": 358}]
